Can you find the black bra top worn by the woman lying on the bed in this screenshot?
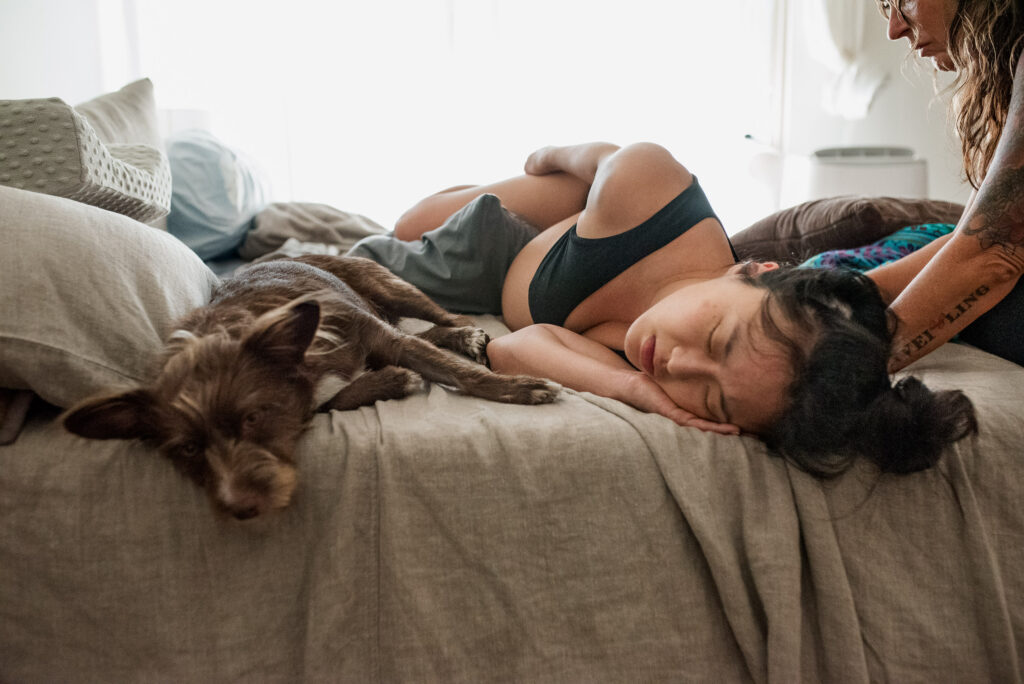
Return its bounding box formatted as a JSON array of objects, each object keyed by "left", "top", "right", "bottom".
[{"left": 529, "top": 176, "right": 736, "bottom": 326}]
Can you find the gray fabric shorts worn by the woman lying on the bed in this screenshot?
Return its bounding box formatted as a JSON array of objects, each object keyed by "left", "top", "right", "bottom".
[{"left": 348, "top": 195, "right": 538, "bottom": 315}]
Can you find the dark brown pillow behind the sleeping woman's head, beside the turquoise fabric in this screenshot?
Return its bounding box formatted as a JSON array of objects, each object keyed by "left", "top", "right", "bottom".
[{"left": 730, "top": 197, "right": 964, "bottom": 262}]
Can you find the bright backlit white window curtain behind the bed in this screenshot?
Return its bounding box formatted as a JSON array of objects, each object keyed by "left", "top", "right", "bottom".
[{"left": 111, "top": 0, "right": 785, "bottom": 229}]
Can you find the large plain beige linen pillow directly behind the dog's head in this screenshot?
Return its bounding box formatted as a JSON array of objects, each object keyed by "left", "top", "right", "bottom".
[{"left": 0, "top": 186, "right": 217, "bottom": 407}]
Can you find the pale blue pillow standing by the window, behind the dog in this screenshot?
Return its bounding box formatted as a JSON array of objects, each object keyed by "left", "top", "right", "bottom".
[{"left": 167, "top": 130, "right": 268, "bottom": 259}]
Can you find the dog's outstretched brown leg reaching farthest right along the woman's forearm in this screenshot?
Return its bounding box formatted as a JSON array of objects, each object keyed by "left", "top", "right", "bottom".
[{"left": 369, "top": 326, "right": 559, "bottom": 403}]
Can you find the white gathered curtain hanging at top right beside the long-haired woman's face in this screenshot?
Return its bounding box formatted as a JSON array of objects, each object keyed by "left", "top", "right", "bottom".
[{"left": 803, "top": 0, "right": 888, "bottom": 119}]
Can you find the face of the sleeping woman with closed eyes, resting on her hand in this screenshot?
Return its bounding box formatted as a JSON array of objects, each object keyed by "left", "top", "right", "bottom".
[{"left": 625, "top": 264, "right": 793, "bottom": 432}]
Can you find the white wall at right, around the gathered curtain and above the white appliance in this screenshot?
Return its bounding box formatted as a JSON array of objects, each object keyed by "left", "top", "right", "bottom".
[{"left": 783, "top": 0, "right": 971, "bottom": 202}]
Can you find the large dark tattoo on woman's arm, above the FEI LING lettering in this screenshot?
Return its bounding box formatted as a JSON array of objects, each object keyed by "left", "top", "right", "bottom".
[{"left": 964, "top": 162, "right": 1024, "bottom": 257}]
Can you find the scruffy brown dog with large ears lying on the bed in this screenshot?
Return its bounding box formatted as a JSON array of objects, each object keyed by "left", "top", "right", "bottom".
[{"left": 63, "top": 256, "right": 558, "bottom": 519}]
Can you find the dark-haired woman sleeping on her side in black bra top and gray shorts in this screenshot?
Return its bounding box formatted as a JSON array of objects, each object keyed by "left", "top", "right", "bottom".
[{"left": 350, "top": 143, "right": 975, "bottom": 475}]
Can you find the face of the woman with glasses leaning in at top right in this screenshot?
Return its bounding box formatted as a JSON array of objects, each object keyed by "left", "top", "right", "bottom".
[{"left": 877, "top": 0, "right": 956, "bottom": 72}]
